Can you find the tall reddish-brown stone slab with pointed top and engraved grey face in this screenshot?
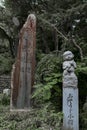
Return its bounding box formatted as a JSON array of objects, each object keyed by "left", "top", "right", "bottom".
[{"left": 10, "top": 14, "right": 36, "bottom": 110}]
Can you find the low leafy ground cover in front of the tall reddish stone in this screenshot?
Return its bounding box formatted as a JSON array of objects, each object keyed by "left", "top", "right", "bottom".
[{"left": 0, "top": 104, "right": 63, "bottom": 130}]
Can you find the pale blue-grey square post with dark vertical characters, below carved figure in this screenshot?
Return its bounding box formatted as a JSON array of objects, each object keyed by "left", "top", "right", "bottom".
[{"left": 63, "top": 87, "right": 79, "bottom": 130}]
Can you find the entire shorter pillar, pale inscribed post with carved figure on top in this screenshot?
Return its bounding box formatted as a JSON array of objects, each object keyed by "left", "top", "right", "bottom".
[{"left": 63, "top": 51, "right": 79, "bottom": 130}]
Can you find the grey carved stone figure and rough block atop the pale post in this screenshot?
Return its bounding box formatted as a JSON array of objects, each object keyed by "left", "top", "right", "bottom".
[{"left": 63, "top": 51, "right": 78, "bottom": 87}]
